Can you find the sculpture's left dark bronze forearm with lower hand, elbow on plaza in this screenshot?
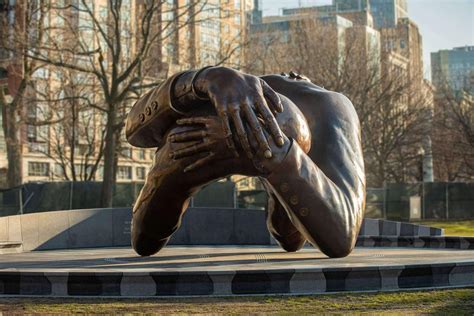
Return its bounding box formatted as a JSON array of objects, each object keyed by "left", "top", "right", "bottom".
[{"left": 132, "top": 121, "right": 249, "bottom": 256}]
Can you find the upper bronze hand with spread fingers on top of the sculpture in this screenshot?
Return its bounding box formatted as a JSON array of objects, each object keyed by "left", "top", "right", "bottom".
[{"left": 194, "top": 67, "right": 285, "bottom": 159}]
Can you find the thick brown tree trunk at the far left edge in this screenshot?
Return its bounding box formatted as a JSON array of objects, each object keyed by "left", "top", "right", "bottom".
[{"left": 0, "top": 89, "right": 23, "bottom": 188}]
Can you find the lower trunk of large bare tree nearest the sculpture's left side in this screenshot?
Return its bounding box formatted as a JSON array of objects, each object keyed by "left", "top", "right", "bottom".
[{"left": 101, "top": 110, "right": 117, "bottom": 207}]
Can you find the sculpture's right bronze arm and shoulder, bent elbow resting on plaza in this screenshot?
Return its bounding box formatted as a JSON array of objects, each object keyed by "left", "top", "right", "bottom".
[{"left": 265, "top": 84, "right": 365, "bottom": 257}]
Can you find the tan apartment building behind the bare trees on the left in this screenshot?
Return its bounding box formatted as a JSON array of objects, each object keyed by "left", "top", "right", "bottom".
[{"left": 0, "top": 0, "right": 253, "bottom": 186}]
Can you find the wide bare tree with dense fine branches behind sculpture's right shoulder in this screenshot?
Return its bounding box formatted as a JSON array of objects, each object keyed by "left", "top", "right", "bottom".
[{"left": 247, "top": 17, "right": 430, "bottom": 186}]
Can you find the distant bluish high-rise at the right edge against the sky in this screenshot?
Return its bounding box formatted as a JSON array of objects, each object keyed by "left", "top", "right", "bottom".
[{"left": 431, "top": 46, "right": 474, "bottom": 95}]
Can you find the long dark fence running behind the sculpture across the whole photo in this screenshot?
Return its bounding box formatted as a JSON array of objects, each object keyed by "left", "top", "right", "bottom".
[{"left": 0, "top": 181, "right": 474, "bottom": 221}]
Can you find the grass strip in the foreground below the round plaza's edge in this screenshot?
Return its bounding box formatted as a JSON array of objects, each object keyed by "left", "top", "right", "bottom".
[{"left": 0, "top": 289, "right": 474, "bottom": 315}]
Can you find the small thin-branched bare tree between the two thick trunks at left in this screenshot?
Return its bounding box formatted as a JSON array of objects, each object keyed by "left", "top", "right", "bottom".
[{"left": 34, "top": 68, "right": 105, "bottom": 181}]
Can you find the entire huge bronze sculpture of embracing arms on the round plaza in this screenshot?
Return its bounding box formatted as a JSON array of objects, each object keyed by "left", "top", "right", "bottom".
[{"left": 126, "top": 67, "right": 365, "bottom": 257}]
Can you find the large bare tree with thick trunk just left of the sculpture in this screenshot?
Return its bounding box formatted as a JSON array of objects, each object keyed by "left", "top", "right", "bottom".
[{"left": 28, "top": 0, "right": 224, "bottom": 207}]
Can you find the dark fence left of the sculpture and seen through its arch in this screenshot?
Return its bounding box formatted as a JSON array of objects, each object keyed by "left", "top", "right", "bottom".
[{"left": 0, "top": 181, "right": 267, "bottom": 216}]
